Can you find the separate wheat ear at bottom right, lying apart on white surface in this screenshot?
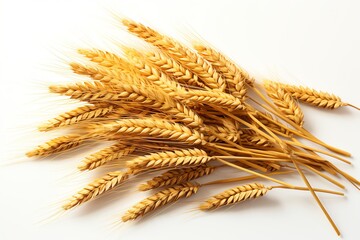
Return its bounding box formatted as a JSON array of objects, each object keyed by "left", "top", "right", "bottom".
[{"left": 199, "top": 183, "right": 269, "bottom": 210}]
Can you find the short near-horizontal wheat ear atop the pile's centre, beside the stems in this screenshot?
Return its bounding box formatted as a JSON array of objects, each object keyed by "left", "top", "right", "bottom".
[{"left": 183, "top": 90, "right": 245, "bottom": 110}]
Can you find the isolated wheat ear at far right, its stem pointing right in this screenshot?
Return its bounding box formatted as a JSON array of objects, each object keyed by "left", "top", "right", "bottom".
[{"left": 272, "top": 82, "right": 360, "bottom": 110}]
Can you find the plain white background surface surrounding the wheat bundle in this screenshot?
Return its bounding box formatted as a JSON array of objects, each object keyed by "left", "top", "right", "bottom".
[{"left": 0, "top": 0, "right": 360, "bottom": 240}]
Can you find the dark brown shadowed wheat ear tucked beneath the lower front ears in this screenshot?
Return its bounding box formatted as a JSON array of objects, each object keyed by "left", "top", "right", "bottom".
[{"left": 139, "top": 164, "right": 215, "bottom": 191}]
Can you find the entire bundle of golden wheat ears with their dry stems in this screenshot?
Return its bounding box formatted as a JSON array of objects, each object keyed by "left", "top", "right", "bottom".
[{"left": 27, "top": 19, "right": 360, "bottom": 234}]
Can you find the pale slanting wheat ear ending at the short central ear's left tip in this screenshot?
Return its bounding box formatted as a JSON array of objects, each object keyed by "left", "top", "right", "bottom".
[{"left": 125, "top": 48, "right": 186, "bottom": 98}]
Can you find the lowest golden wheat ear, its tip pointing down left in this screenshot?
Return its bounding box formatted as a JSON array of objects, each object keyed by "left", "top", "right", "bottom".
[{"left": 122, "top": 182, "right": 199, "bottom": 222}]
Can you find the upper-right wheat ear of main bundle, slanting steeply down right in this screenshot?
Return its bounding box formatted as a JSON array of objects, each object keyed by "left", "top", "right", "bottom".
[{"left": 194, "top": 44, "right": 254, "bottom": 101}]
